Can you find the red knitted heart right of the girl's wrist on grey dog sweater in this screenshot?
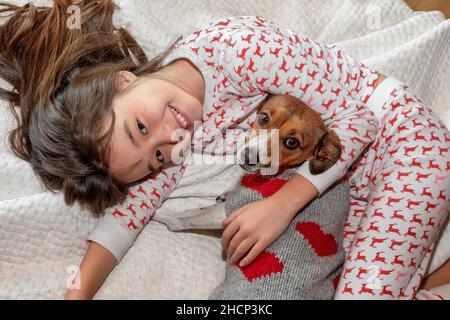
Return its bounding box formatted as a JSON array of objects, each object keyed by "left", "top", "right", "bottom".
[{"left": 295, "top": 222, "right": 338, "bottom": 257}]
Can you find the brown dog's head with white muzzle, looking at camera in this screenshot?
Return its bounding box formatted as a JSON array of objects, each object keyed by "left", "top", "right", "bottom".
[{"left": 239, "top": 95, "right": 342, "bottom": 174}]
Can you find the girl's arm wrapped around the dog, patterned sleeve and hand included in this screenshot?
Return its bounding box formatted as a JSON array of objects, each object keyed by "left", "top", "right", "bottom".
[{"left": 222, "top": 16, "right": 379, "bottom": 265}]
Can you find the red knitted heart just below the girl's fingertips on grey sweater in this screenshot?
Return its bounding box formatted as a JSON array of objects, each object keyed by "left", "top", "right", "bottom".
[{"left": 237, "top": 251, "right": 284, "bottom": 282}]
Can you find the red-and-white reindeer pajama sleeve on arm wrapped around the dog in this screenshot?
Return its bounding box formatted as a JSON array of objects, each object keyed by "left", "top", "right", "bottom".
[{"left": 226, "top": 16, "right": 378, "bottom": 194}]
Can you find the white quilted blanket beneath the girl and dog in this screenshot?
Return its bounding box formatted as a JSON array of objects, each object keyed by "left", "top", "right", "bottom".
[{"left": 0, "top": 0, "right": 450, "bottom": 299}]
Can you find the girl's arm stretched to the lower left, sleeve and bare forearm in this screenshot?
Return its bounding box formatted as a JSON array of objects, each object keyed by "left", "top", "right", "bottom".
[{"left": 65, "top": 165, "right": 184, "bottom": 299}]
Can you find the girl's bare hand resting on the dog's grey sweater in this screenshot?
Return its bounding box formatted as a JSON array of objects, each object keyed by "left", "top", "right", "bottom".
[{"left": 222, "top": 197, "right": 296, "bottom": 267}]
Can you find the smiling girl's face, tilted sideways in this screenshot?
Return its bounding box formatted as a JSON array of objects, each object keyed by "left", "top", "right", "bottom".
[{"left": 109, "top": 71, "right": 203, "bottom": 184}]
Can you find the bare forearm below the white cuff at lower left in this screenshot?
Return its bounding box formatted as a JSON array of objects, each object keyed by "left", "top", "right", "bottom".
[{"left": 64, "top": 242, "right": 117, "bottom": 300}]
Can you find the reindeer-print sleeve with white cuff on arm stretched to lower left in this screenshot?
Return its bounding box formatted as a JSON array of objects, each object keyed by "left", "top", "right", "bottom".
[{"left": 87, "top": 165, "right": 184, "bottom": 263}]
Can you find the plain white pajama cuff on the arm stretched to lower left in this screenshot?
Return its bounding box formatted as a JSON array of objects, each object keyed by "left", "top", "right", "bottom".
[{"left": 87, "top": 214, "right": 135, "bottom": 264}]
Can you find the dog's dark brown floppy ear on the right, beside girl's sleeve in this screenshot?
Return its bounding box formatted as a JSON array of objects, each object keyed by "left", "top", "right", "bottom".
[{"left": 309, "top": 130, "right": 342, "bottom": 174}]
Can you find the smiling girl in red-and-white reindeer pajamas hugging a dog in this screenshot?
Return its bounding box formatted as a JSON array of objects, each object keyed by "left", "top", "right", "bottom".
[{"left": 0, "top": 0, "right": 450, "bottom": 298}]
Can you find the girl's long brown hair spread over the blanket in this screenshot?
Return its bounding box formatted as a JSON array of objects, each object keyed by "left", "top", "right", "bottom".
[{"left": 0, "top": 0, "right": 181, "bottom": 214}]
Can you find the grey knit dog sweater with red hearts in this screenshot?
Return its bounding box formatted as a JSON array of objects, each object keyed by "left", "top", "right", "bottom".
[{"left": 209, "top": 169, "right": 350, "bottom": 300}]
